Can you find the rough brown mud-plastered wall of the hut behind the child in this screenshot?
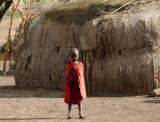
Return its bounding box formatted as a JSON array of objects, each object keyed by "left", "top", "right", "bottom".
[{"left": 15, "top": 2, "right": 160, "bottom": 95}]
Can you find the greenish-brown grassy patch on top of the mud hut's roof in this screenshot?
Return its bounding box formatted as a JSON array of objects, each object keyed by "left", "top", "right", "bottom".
[{"left": 46, "top": 0, "right": 130, "bottom": 25}]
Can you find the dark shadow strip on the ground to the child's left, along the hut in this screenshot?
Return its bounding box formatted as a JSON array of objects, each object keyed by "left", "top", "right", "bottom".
[{"left": 0, "top": 85, "right": 63, "bottom": 98}]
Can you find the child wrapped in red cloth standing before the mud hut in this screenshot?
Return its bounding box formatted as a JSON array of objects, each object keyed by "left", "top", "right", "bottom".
[{"left": 64, "top": 48, "right": 86, "bottom": 119}]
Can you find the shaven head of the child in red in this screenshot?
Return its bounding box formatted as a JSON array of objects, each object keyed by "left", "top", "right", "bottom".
[{"left": 70, "top": 48, "right": 79, "bottom": 62}]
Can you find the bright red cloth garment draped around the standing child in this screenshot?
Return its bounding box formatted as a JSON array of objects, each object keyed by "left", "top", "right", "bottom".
[{"left": 64, "top": 63, "right": 86, "bottom": 104}]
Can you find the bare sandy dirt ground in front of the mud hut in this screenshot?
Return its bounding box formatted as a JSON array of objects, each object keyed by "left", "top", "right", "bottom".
[{"left": 0, "top": 76, "right": 160, "bottom": 122}]
